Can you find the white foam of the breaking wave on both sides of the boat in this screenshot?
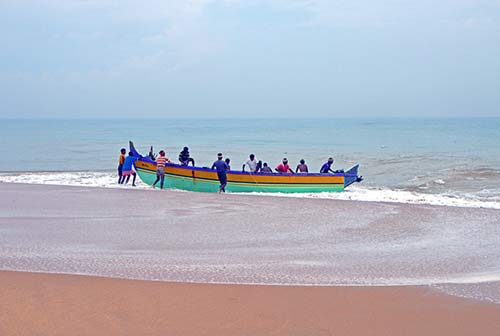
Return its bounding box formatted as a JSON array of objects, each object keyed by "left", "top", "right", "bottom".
[{"left": 0, "top": 172, "right": 500, "bottom": 209}]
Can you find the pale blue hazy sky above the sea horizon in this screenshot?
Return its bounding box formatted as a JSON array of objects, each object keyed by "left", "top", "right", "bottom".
[{"left": 0, "top": 0, "right": 500, "bottom": 118}]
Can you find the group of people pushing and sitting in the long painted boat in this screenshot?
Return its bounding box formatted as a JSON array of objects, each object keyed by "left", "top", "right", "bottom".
[{"left": 118, "top": 147, "right": 341, "bottom": 192}]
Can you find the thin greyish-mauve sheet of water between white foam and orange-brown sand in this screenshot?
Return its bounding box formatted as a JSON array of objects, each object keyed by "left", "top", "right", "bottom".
[{"left": 0, "top": 184, "right": 500, "bottom": 302}]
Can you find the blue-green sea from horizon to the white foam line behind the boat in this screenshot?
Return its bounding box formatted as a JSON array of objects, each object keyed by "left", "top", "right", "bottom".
[{"left": 0, "top": 118, "right": 500, "bottom": 208}]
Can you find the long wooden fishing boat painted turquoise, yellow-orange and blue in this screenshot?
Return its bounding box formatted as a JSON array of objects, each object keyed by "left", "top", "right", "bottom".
[{"left": 130, "top": 142, "right": 362, "bottom": 193}]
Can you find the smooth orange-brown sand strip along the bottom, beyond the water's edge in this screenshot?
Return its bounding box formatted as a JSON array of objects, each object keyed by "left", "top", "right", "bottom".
[{"left": 0, "top": 271, "right": 500, "bottom": 336}]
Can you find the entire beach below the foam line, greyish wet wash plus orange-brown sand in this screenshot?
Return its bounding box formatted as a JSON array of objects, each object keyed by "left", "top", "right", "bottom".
[{"left": 0, "top": 183, "right": 500, "bottom": 335}]
